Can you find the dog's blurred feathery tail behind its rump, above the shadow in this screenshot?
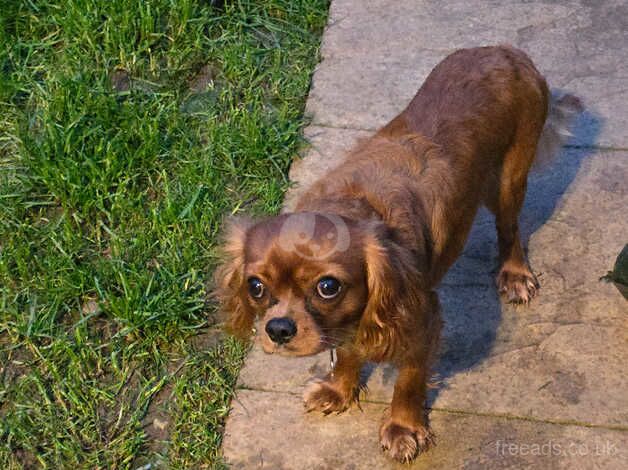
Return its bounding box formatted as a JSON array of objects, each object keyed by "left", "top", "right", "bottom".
[{"left": 534, "top": 94, "right": 584, "bottom": 169}]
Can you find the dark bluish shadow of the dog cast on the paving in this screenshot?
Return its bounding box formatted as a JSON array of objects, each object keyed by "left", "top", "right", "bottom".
[{"left": 363, "top": 102, "right": 601, "bottom": 407}]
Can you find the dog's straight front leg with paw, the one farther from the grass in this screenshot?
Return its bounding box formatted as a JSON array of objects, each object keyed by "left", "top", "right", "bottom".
[{"left": 379, "top": 361, "right": 433, "bottom": 462}]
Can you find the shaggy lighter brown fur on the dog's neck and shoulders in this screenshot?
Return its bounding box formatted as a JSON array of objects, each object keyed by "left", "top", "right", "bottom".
[{"left": 295, "top": 134, "right": 461, "bottom": 284}]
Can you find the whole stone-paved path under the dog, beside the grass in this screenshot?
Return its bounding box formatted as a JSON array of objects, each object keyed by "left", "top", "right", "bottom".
[{"left": 224, "top": 0, "right": 628, "bottom": 469}]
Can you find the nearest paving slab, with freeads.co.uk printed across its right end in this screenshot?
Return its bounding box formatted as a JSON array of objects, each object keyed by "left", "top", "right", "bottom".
[{"left": 224, "top": 390, "right": 628, "bottom": 470}]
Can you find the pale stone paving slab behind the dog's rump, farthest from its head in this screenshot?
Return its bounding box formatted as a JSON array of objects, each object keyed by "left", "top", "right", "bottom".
[{"left": 307, "top": 0, "right": 628, "bottom": 148}]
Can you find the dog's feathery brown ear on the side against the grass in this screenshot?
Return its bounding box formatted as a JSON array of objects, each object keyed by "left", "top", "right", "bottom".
[{"left": 214, "top": 217, "right": 255, "bottom": 338}]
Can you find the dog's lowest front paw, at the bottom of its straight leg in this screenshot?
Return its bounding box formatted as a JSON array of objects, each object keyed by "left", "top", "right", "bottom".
[{"left": 379, "top": 418, "right": 434, "bottom": 463}]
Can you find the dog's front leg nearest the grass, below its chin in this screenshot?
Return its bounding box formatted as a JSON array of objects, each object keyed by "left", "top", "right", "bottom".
[{"left": 303, "top": 347, "right": 363, "bottom": 414}]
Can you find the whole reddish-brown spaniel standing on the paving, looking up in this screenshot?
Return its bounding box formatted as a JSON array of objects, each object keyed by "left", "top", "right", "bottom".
[{"left": 216, "top": 46, "right": 580, "bottom": 461}]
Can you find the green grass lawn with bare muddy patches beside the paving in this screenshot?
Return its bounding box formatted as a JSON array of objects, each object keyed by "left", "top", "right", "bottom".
[{"left": 0, "top": 0, "right": 327, "bottom": 469}]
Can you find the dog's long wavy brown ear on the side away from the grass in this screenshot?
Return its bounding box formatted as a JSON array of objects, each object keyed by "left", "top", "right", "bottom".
[{"left": 356, "top": 224, "right": 425, "bottom": 361}]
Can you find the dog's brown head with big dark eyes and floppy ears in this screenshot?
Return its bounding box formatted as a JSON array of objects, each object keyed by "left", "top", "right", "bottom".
[{"left": 216, "top": 212, "right": 429, "bottom": 359}]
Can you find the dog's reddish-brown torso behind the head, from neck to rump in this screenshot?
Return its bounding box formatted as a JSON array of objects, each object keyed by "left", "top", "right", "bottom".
[{"left": 296, "top": 46, "right": 580, "bottom": 288}]
